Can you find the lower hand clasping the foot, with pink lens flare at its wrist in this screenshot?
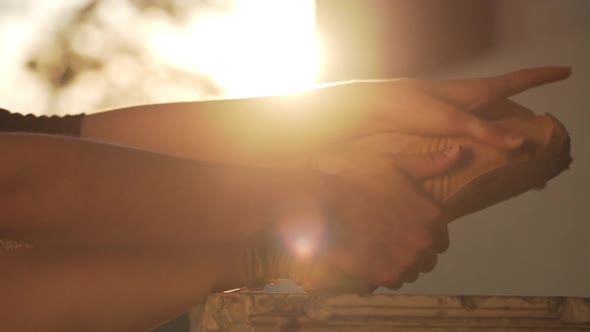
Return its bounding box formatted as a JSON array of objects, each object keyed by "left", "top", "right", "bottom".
[{"left": 279, "top": 147, "right": 460, "bottom": 291}]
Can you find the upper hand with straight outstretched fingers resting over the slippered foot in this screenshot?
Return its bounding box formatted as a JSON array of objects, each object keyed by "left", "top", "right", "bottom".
[{"left": 293, "top": 67, "right": 571, "bottom": 153}]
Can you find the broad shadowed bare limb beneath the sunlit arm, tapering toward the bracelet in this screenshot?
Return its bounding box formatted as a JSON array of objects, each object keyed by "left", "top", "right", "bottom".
[{"left": 0, "top": 134, "right": 320, "bottom": 331}]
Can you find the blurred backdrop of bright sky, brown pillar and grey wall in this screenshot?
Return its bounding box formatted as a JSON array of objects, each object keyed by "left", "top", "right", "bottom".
[{"left": 0, "top": 0, "right": 590, "bottom": 331}]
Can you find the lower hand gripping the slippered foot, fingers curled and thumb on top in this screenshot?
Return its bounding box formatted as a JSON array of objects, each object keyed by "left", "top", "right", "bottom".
[{"left": 308, "top": 146, "right": 461, "bottom": 292}]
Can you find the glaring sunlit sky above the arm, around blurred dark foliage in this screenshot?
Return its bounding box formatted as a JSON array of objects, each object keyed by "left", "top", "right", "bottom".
[{"left": 0, "top": 0, "right": 319, "bottom": 114}]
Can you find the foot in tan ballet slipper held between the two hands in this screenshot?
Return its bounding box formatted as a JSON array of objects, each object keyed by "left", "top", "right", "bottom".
[{"left": 402, "top": 102, "right": 572, "bottom": 220}]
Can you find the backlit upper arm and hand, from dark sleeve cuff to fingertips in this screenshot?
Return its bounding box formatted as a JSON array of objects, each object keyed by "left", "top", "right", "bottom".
[{"left": 81, "top": 67, "right": 570, "bottom": 164}]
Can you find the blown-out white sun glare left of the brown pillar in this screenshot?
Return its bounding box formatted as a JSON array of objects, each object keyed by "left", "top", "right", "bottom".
[{"left": 150, "top": 0, "right": 318, "bottom": 97}]
